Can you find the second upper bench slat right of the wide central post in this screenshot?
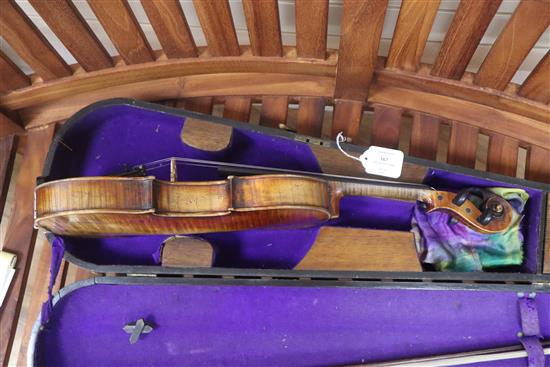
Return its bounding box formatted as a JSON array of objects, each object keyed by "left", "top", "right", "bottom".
[{"left": 431, "top": 0, "right": 502, "bottom": 79}]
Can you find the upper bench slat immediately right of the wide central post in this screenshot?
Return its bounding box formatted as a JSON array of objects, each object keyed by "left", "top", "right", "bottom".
[{"left": 386, "top": 0, "right": 439, "bottom": 71}]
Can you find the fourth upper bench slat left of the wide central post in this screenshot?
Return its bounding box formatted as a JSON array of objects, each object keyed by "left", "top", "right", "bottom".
[{"left": 141, "top": 0, "right": 197, "bottom": 58}]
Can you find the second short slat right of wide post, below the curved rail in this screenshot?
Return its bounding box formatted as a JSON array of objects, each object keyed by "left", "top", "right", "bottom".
[{"left": 409, "top": 112, "right": 440, "bottom": 160}]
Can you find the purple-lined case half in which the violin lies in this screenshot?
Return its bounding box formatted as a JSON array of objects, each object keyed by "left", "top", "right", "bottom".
[{"left": 41, "top": 99, "right": 549, "bottom": 282}]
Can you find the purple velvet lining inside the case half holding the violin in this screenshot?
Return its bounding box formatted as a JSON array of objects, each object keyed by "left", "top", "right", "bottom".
[{"left": 48, "top": 105, "right": 540, "bottom": 272}]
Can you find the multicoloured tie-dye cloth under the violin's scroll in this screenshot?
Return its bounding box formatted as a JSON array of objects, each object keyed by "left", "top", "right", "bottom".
[{"left": 412, "top": 188, "right": 529, "bottom": 271}]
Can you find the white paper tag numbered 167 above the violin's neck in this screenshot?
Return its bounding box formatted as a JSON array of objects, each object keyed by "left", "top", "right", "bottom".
[{"left": 359, "top": 146, "right": 404, "bottom": 178}]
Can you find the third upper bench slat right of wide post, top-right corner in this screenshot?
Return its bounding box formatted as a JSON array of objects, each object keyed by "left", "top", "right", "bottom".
[{"left": 474, "top": 0, "right": 550, "bottom": 90}]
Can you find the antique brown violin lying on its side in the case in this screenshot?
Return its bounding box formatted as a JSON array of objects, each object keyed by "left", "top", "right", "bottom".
[{"left": 35, "top": 158, "right": 513, "bottom": 236}]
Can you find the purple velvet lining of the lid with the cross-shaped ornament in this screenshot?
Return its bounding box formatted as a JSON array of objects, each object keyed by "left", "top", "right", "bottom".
[{"left": 35, "top": 284, "right": 550, "bottom": 367}]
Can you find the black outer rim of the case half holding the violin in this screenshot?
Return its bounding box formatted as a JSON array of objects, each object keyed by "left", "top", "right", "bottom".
[{"left": 38, "top": 99, "right": 550, "bottom": 288}]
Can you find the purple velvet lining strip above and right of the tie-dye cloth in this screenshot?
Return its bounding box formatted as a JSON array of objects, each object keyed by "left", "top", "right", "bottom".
[{"left": 424, "top": 169, "right": 542, "bottom": 273}]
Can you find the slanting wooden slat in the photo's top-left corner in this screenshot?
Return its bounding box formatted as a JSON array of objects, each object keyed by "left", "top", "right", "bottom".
[{"left": 0, "top": 1, "right": 72, "bottom": 80}]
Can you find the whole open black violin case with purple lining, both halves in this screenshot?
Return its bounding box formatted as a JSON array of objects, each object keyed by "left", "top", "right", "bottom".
[{"left": 29, "top": 99, "right": 550, "bottom": 366}]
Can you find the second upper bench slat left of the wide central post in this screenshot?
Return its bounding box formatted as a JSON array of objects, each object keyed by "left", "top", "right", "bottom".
[{"left": 242, "top": 0, "right": 283, "bottom": 56}]
